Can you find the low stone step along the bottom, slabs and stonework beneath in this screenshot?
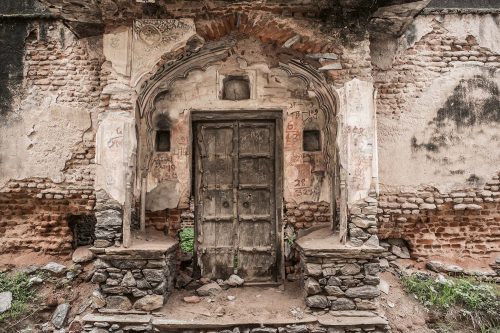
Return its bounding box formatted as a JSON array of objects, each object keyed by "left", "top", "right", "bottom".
[{"left": 83, "top": 311, "right": 390, "bottom": 333}]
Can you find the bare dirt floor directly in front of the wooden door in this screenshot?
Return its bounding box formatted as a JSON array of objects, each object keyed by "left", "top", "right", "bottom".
[{"left": 160, "top": 282, "right": 308, "bottom": 323}]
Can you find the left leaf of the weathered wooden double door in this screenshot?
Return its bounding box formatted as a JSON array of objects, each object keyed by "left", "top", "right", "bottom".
[{"left": 195, "top": 122, "right": 237, "bottom": 277}]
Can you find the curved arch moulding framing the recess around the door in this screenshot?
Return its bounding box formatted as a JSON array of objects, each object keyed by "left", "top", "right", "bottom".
[{"left": 133, "top": 30, "right": 347, "bottom": 240}]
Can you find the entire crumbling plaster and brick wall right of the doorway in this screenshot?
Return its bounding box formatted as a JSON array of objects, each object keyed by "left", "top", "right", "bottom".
[{"left": 374, "top": 14, "right": 500, "bottom": 256}]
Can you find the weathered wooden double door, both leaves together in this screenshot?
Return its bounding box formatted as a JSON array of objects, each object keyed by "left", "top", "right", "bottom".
[{"left": 195, "top": 120, "right": 277, "bottom": 281}]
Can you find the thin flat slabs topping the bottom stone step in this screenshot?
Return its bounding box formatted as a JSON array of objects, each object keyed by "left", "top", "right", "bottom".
[{"left": 83, "top": 311, "right": 388, "bottom": 330}]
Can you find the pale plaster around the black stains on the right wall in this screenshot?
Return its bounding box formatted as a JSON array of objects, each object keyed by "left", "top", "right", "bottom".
[{"left": 378, "top": 66, "right": 500, "bottom": 191}]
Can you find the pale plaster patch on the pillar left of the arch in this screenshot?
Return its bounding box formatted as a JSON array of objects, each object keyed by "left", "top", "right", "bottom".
[{"left": 95, "top": 111, "right": 137, "bottom": 204}]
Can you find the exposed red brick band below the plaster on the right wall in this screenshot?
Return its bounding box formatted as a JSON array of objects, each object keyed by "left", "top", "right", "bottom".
[{"left": 378, "top": 176, "right": 500, "bottom": 257}]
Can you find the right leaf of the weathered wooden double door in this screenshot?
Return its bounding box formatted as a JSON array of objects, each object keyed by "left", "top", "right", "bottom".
[{"left": 238, "top": 121, "right": 276, "bottom": 281}]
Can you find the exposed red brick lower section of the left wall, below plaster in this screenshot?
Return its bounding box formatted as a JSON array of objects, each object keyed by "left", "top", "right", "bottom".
[{"left": 0, "top": 142, "right": 95, "bottom": 253}]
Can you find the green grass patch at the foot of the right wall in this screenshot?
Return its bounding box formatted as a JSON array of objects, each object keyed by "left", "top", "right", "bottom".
[{"left": 403, "top": 274, "right": 500, "bottom": 333}]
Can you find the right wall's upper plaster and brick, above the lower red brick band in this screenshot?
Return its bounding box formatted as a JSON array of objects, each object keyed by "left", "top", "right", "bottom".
[{"left": 375, "top": 14, "right": 500, "bottom": 191}]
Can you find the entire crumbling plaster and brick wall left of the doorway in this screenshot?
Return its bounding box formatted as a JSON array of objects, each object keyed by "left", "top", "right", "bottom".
[{"left": 0, "top": 20, "right": 101, "bottom": 253}]
